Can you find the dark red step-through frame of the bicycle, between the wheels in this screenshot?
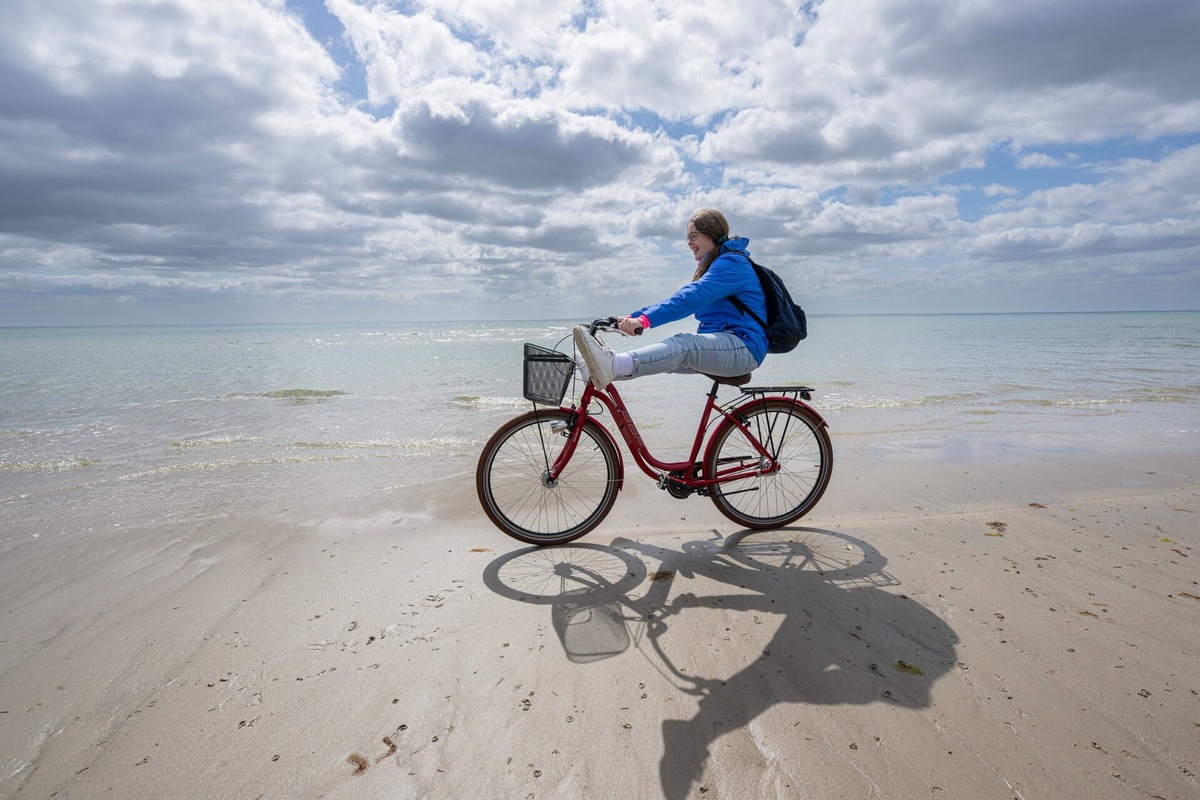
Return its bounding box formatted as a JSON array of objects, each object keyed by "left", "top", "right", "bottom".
[{"left": 548, "top": 381, "right": 801, "bottom": 492}]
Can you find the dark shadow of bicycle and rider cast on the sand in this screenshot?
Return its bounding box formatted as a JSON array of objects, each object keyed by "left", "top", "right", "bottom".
[{"left": 485, "top": 528, "right": 958, "bottom": 799}]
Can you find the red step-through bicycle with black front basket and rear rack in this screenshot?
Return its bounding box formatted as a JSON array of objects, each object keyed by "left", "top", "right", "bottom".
[{"left": 475, "top": 318, "right": 833, "bottom": 545}]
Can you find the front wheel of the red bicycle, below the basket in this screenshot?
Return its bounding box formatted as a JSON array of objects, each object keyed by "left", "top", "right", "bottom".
[{"left": 475, "top": 409, "right": 620, "bottom": 545}]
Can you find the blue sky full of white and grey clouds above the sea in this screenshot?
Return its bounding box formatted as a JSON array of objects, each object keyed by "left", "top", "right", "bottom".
[{"left": 0, "top": 0, "right": 1200, "bottom": 326}]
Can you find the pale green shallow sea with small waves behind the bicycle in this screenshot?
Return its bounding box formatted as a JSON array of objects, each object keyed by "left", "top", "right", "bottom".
[{"left": 0, "top": 312, "right": 1200, "bottom": 541}]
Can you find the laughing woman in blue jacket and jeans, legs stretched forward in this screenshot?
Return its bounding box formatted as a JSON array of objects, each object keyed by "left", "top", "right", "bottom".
[{"left": 575, "top": 209, "right": 767, "bottom": 389}]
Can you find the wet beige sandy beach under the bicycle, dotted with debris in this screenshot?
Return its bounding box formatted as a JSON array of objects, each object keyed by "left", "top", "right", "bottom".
[{"left": 0, "top": 441, "right": 1200, "bottom": 800}]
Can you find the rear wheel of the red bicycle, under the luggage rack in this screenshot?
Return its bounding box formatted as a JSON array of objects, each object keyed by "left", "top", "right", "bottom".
[{"left": 704, "top": 399, "right": 833, "bottom": 530}]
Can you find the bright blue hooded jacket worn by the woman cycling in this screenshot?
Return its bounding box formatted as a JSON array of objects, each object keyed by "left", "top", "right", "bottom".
[{"left": 630, "top": 237, "right": 767, "bottom": 363}]
